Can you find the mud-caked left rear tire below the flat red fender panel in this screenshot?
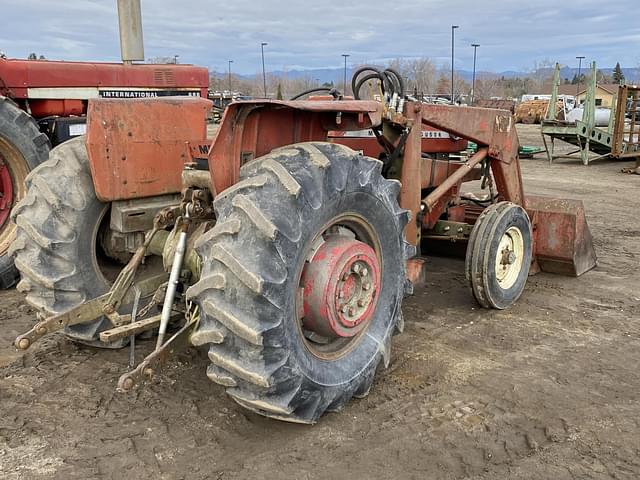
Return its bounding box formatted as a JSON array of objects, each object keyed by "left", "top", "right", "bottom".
[{"left": 12, "top": 136, "right": 123, "bottom": 348}]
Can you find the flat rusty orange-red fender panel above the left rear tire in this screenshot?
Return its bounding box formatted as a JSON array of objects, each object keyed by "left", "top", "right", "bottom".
[{"left": 86, "top": 97, "right": 211, "bottom": 202}]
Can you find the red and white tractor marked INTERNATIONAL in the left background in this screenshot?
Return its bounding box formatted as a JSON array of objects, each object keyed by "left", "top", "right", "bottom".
[{"left": 0, "top": 58, "right": 209, "bottom": 288}]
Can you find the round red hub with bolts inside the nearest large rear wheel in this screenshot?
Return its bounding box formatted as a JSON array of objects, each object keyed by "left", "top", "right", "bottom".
[{"left": 301, "top": 234, "right": 380, "bottom": 338}]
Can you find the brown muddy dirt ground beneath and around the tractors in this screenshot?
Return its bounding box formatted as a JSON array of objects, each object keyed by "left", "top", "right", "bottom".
[{"left": 0, "top": 126, "right": 640, "bottom": 480}]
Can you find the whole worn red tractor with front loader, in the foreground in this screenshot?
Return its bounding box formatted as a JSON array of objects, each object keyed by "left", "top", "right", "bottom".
[{"left": 12, "top": 62, "right": 596, "bottom": 423}]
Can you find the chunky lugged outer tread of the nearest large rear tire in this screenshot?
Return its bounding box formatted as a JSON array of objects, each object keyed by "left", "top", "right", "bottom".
[{"left": 187, "top": 142, "right": 411, "bottom": 423}]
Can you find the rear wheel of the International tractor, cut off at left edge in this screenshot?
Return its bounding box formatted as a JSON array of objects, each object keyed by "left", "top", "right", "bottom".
[{"left": 0, "top": 96, "right": 50, "bottom": 289}]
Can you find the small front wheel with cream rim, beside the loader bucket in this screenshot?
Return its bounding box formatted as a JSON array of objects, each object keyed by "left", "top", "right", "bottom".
[{"left": 465, "top": 202, "right": 533, "bottom": 310}]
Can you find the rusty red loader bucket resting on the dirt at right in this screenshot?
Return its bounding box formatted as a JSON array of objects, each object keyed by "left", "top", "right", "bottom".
[{"left": 526, "top": 195, "right": 597, "bottom": 277}]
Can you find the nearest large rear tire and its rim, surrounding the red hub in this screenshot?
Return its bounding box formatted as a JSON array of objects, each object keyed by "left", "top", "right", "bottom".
[{"left": 187, "top": 143, "right": 414, "bottom": 423}]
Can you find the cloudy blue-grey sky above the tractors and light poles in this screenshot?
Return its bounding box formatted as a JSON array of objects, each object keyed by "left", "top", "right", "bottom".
[{"left": 0, "top": 0, "right": 640, "bottom": 75}]
